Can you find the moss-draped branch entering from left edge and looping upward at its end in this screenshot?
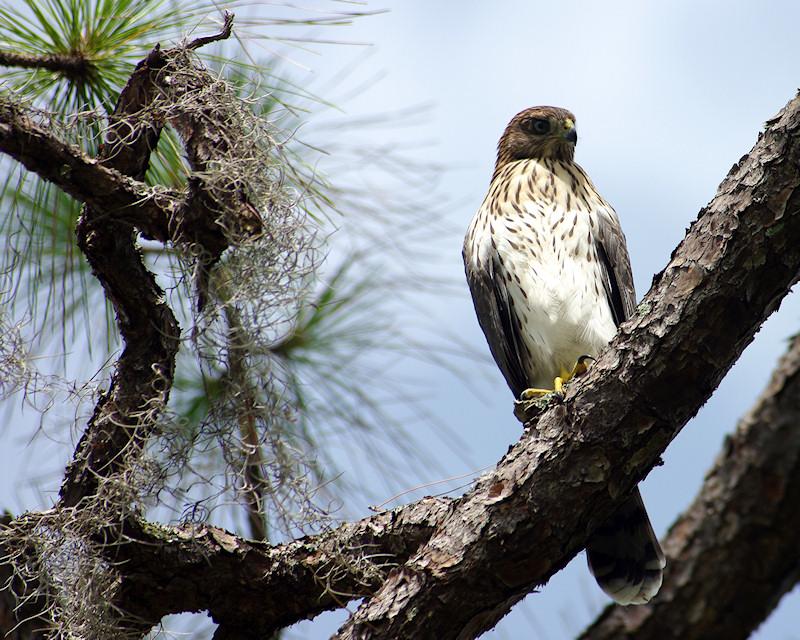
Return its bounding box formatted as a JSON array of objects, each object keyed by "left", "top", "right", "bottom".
[{"left": 0, "top": 12, "right": 262, "bottom": 259}]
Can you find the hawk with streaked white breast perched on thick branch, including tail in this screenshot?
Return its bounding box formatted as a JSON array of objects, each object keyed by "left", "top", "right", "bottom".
[{"left": 463, "top": 107, "right": 665, "bottom": 604}]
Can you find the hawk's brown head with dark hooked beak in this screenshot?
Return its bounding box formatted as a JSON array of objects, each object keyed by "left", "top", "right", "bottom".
[{"left": 496, "top": 107, "right": 578, "bottom": 168}]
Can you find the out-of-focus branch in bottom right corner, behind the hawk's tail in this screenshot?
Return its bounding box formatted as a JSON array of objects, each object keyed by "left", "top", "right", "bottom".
[{"left": 581, "top": 336, "right": 800, "bottom": 640}]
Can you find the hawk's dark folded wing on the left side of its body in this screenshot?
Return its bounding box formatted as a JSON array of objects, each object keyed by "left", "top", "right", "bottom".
[{"left": 464, "top": 252, "right": 530, "bottom": 397}]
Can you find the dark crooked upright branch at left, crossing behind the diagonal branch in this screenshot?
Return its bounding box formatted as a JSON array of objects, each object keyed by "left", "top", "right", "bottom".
[{"left": 60, "top": 48, "right": 180, "bottom": 507}]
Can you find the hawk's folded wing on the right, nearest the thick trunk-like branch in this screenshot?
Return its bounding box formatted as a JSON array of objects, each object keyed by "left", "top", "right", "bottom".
[{"left": 595, "top": 215, "right": 636, "bottom": 326}]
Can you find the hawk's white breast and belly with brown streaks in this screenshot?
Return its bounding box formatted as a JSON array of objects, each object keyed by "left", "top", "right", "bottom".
[{"left": 464, "top": 159, "right": 618, "bottom": 388}]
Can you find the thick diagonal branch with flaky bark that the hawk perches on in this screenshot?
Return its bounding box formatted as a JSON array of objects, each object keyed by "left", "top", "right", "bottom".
[{"left": 336, "top": 92, "right": 800, "bottom": 639}]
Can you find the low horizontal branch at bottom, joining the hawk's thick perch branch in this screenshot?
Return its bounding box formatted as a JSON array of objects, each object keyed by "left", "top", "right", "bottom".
[{"left": 107, "top": 498, "right": 450, "bottom": 638}]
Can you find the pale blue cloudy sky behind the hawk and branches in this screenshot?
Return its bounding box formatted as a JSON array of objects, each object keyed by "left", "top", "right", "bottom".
[{"left": 0, "top": 0, "right": 800, "bottom": 640}]
